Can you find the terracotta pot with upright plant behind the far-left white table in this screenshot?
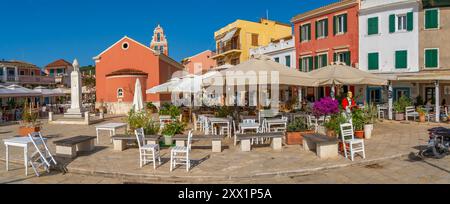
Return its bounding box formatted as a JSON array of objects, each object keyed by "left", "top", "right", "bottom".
[{"left": 19, "top": 103, "right": 41, "bottom": 137}]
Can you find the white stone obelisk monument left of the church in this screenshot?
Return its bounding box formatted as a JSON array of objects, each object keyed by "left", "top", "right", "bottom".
[{"left": 64, "top": 59, "right": 83, "bottom": 118}]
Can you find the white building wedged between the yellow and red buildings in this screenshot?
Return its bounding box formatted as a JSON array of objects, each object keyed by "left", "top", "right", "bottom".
[{"left": 250, "top": 37, "right": 297, "bottom": 69}]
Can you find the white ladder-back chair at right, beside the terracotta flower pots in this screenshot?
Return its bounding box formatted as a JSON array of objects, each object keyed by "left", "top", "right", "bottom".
[{"left": 341, "top": 123, "right": 366, "bottom": 161}]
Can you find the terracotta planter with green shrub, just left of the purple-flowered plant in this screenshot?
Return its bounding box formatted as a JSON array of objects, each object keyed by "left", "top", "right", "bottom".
[{"left": 286, "top": 119, "right": 314, "bottom": 145}]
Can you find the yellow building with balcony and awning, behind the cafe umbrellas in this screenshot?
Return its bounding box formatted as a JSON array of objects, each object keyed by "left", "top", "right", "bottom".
[{"left": 213, "top": 19, "right": 292, "bottom": 66}]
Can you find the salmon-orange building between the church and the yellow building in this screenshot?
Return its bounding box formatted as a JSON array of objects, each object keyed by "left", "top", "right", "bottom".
[{"left": 181, "top": 50, "right": 217, "bottom": 75}]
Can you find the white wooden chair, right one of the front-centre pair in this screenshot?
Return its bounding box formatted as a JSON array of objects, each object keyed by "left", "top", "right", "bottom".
[{"left": 170, "top": 131, "right": 192, "bottom": 172}]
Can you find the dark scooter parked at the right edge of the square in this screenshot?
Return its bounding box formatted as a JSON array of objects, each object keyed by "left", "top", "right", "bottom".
[{"left": 419, "top": 127, "right": 450, "bottom": 159}]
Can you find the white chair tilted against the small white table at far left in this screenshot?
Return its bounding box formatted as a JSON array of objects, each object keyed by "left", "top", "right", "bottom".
[{"left": 28, "top": 132, "right": 57, "bottom": 177}]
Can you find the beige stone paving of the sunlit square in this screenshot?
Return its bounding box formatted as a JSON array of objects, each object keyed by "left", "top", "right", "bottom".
[{"left": 0, "top": 118, "right": 450, "bottom": 181}]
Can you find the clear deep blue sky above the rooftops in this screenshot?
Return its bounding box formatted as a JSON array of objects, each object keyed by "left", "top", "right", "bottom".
[{"left": 0, "top": 0, "right": 336, "bottom": 67}]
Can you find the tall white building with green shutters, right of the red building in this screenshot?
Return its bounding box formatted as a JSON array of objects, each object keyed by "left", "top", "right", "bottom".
[{"left": 359, "top": 0, "right": 420, "bottom": 107}]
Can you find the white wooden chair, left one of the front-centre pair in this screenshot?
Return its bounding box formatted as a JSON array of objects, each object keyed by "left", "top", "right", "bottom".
[{"left": 134, "top": 128, "right": 161, "bottom": 169}]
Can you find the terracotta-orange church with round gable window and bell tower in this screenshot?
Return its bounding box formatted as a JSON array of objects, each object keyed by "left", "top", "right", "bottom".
[{"left": 94, "top": 25, "right": 184, "bottom": 114}]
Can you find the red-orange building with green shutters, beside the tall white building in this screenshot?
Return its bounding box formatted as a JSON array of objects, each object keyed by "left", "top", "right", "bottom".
[{"left": 291, "top": 0, "right": 359, "bottom": 100}]
